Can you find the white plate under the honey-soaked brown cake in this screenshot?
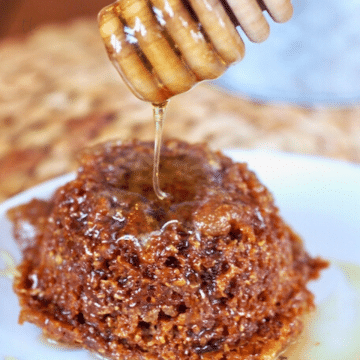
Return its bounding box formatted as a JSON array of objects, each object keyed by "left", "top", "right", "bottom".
[{"left": 0, "top": 150, "right": 360, "bottom": 360}]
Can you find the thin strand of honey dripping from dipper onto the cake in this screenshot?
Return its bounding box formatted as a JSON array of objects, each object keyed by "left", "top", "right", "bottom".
[{"left": 153, "top": 101, "right": 169, "bottom": 200}]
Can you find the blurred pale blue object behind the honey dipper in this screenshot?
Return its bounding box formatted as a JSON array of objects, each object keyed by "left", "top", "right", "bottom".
[{"left": 218, "top": 0, "right": 360, "bottom": 106}]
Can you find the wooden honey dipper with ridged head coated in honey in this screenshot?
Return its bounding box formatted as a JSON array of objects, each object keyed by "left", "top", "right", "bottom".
[{"left": 98, "top": 0, "right": 293, "bottom": 104}]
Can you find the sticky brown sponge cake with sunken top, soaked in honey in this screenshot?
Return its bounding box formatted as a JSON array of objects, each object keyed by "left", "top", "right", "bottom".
[{"left": 9, "top": 140, "right": 327, "bottom": 360}]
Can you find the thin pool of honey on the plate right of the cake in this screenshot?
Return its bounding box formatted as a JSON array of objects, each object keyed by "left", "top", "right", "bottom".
[{"left": 280, "top": 260, "right": 360, "bottom": 360}]
